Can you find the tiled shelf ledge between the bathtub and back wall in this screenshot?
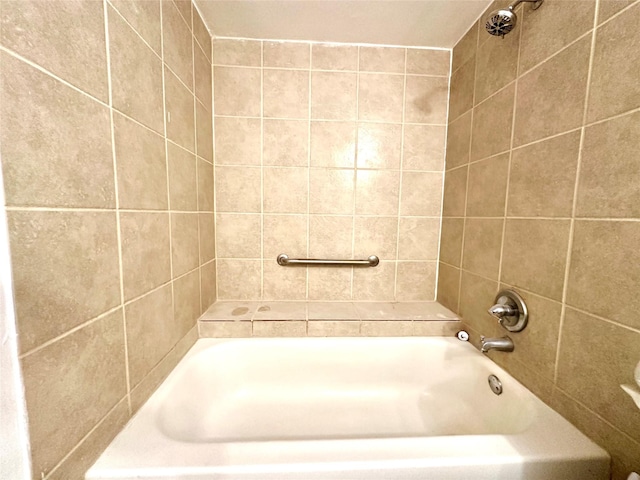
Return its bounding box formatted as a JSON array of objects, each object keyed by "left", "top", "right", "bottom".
[{"left": 198, "top": 301, "right": 461, "bottom": 338}]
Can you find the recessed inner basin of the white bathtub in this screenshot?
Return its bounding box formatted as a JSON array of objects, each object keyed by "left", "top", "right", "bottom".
[{"left": 157, "top": 338, "right": 535, "bottom": 443}]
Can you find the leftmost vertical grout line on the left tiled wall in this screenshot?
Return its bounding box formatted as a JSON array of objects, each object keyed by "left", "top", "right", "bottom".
[{"left": 102, "top": 1, "right": 132, "bottom": 415}]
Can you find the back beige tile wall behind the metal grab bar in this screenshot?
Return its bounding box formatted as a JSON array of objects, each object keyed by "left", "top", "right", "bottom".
[{"left": 213, "top": 39, "right": 450, "bottom": 301}]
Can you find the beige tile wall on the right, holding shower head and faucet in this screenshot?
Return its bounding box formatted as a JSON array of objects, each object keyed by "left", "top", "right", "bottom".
[{"left": 438, "top": 0, "right": 640, "bottom": 472}]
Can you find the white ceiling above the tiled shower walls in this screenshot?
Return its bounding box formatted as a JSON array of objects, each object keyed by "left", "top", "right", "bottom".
[{"left": 195, "top": 0, "right": 491, "bottom": 48}]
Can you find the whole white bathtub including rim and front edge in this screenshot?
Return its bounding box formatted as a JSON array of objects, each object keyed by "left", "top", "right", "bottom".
[{"left": 86, "top": 337, "right": 609, "bottom": 480}]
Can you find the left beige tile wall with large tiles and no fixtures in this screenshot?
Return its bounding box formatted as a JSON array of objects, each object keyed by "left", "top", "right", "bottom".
[{"left": 0, "top": 0, "right": 216, "bottom": 480}]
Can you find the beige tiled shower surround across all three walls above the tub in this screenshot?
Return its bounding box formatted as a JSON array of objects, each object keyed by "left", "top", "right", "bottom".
[{"left": 0, "top": 0, "right": 640, "bottom": 480}]
